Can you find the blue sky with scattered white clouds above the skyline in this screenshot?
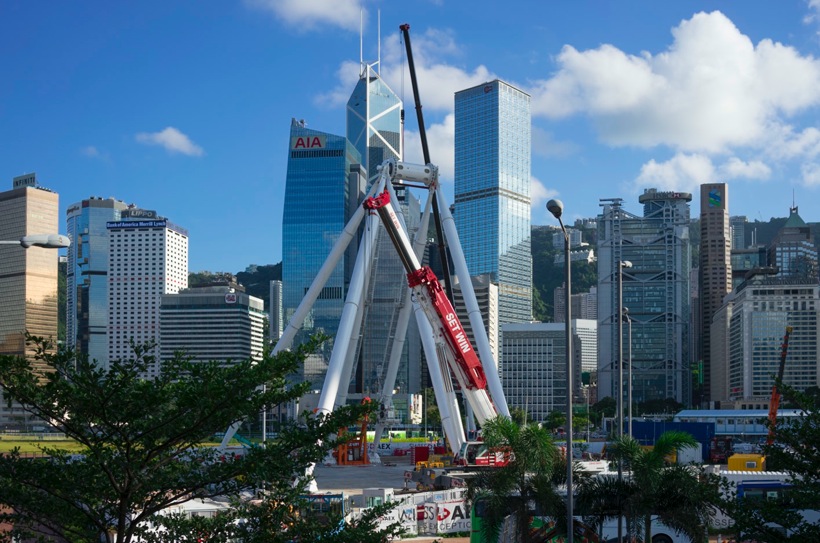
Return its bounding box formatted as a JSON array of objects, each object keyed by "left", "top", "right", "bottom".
[{"left": 0, "top": 0, "right": 820, "bottom": 272}]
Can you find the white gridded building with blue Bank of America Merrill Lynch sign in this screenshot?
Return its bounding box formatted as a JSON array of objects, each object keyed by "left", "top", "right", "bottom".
[{"left": 106, "top": 209, "right": 188, "bottom": 378}]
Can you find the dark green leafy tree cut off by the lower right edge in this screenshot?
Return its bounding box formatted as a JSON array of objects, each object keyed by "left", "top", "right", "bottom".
[{"left": 724, "top": 383, "right": 820, "bottom": 543}]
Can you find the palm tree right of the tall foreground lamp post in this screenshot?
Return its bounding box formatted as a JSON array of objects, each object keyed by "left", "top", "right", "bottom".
[{"left": 577, "top": 431, "right": 719, "bottom": 543}]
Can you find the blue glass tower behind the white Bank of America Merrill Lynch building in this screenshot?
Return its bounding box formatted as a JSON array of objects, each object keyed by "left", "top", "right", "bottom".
[{"left": 66, "top": 197, "right": 128, "bottom": 365}]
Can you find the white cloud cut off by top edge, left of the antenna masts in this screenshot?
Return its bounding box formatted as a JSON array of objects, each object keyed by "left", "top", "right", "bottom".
[{"left": 245, "top": 0, "right": 362, "bottom": 32}]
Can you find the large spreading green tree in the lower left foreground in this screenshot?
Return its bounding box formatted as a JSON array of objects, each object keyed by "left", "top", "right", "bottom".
[{"left": 0, "top": 336, "right": 398, "bottom": 543}]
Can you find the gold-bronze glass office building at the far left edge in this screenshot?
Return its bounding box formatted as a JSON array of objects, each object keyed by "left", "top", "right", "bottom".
[{"left": 0, "top": 173, "right": 59, "bottom": 429}]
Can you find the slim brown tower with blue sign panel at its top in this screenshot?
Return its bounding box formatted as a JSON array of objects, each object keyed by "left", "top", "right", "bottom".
[{"left": 694, "top": 183, "right": 732, "bottom": 402}]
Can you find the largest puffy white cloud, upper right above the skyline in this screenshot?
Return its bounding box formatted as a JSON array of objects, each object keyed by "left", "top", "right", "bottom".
[{"left": 531, "top": 11, "right": 820, "bottom": 153}]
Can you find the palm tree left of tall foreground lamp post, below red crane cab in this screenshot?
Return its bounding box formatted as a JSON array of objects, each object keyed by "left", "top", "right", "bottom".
[{"left": 468, "top": 416, "right": 566, "bottom": 543}]
